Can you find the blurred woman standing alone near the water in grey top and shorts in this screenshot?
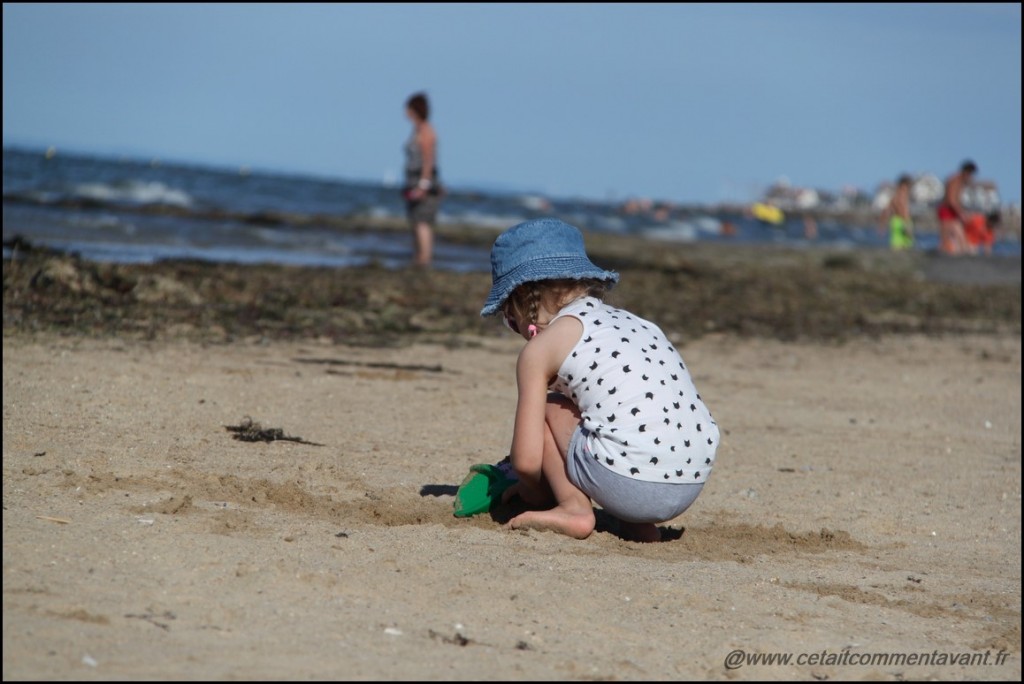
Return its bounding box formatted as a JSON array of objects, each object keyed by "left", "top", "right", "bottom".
[{"left": 402, "top": 92, "right": 443, "bottom": 266}]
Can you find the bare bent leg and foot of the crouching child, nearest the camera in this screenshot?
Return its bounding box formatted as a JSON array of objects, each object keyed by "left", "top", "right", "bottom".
[{"left": 509, "top": 394, "right": 595, "bottom": 539}]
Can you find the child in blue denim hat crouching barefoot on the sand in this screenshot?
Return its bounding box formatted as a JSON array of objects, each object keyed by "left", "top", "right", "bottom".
[{"left": 480, "top": 218, "right": 719, "bottom": 542}]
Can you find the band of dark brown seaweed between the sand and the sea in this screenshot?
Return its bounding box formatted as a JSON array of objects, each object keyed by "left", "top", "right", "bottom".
[{"left": 3, "top": 229, "right": 1021, "bottom": 348}]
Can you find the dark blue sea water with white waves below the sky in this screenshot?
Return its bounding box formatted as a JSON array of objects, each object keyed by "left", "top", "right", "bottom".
[{"left": 3, "top": 147, "right": 1020, "bottom": 271}]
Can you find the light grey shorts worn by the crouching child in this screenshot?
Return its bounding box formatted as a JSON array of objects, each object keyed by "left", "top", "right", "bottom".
[{"left": 565, "top": 426, "right": 703, "bottom": 522}]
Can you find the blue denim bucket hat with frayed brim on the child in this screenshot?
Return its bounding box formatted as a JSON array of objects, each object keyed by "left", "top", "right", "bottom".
[{"left": 480, "top": 218, "right": 618, "bottom": 316}]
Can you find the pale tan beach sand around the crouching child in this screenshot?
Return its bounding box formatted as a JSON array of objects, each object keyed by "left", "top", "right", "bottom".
[{"left": 3, "top": 327, "right": 1021, "bottom": 680}]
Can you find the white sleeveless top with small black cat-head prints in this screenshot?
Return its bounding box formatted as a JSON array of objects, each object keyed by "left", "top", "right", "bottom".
[{"left": 551, "top": 297, "right": 719, "bottom": 483}]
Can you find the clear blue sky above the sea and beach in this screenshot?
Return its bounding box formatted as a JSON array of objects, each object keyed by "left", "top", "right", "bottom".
[{"left": 3, "top": 3, "right": 1021, "bottom": 204}]
